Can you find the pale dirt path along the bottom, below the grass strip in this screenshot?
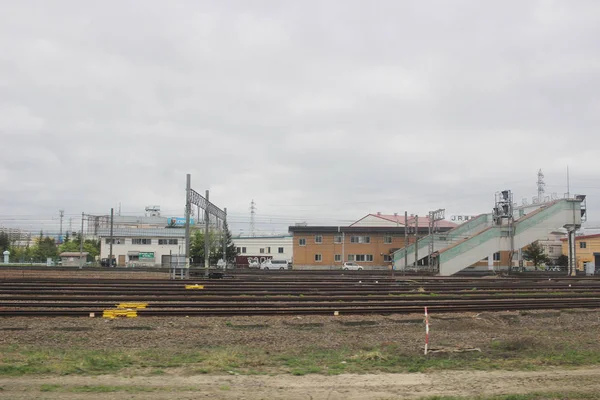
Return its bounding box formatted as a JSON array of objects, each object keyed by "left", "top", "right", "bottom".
[{"left": 0, "top": 367, "right": 600, "bottom": 400}]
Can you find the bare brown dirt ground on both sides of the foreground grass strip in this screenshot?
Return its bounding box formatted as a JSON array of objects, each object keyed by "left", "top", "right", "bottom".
[{"left": 0, "top": 310, "right": 600, "bottom": 400}]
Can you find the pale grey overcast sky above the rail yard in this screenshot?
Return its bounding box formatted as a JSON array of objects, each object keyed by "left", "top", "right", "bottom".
[{"left": 0, "top": 0, "right": 600, "bottom": 236}]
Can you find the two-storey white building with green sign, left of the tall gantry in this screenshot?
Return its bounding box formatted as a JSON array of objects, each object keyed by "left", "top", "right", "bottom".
[{"left": 98, "top": 228, "right": 185, "bottom": 267}]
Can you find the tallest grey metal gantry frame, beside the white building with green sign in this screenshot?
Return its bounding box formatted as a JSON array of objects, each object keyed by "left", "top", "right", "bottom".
[{"left": 185, "top": 174, "right": 227, "bottom": 275}]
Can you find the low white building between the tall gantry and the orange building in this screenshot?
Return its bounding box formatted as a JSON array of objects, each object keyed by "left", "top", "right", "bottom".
[{"left": 233, "top": 235, "right": 294, "bottom": 268}]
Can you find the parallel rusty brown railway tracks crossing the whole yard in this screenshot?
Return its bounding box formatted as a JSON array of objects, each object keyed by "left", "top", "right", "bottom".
[{"left": 0, "top": 274, "right": 600, "bottom": 317}]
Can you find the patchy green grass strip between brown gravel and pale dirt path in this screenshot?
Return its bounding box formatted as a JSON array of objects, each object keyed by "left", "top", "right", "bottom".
[{"left": 0, "top": 336, "right": 600, "bottom": 376}]
